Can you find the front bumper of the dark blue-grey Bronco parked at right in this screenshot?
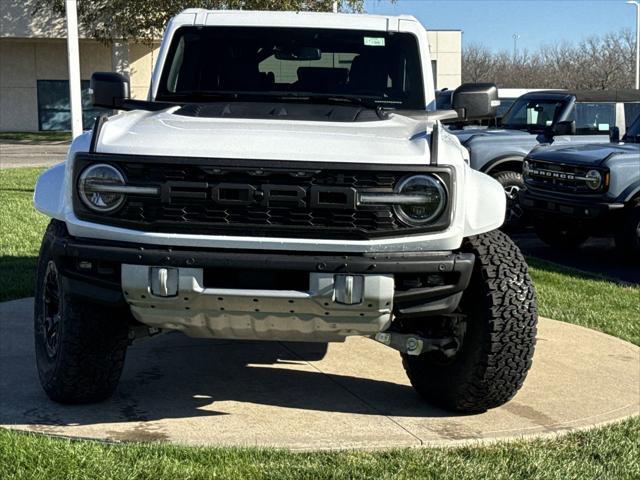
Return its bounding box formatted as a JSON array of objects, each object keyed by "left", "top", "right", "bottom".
[{"left": 519, "top": 190, "right": 624, "bottom": 221}]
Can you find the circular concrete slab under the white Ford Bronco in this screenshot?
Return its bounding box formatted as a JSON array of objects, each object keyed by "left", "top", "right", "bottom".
[{"left": 0, "top": 299, "right": 640, "bottom": 449}]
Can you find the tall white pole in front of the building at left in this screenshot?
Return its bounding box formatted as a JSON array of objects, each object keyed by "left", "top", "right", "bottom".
[{"left": 65, "top": 0, "right": 82, "bottom": 138}]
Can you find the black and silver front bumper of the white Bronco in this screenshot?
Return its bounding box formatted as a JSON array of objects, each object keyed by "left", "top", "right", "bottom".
[{"left": 54, "top": 236, "right": 475, "bottom": 341}]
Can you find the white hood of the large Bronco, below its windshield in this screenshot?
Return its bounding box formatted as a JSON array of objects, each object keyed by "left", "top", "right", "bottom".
[{"left": 96, "top": 107, "right": 429, "bottom": 164}]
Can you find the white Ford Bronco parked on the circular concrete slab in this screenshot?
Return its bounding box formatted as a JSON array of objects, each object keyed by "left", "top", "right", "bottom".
[{"left": 34, "top": 10, "right": 537, "bottom": 412}]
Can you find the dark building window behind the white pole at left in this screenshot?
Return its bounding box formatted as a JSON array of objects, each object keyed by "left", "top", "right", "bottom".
[{"left": 38, "top": 80, "right": 106, "bottom": 130}]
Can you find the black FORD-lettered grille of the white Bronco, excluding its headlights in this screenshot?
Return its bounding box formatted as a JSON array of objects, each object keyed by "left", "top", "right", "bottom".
[{"left": 73, "top": 153, "right": 455, "bottom": 240}]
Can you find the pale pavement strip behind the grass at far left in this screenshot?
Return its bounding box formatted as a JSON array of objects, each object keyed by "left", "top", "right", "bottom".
[{"left": 0, "top": 140, "right": 69, "bottom": 169}]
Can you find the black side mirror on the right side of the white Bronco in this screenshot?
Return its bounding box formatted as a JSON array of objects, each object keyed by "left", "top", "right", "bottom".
[{"left": 451, "top": 83, "right": 500, "bottom": 120}]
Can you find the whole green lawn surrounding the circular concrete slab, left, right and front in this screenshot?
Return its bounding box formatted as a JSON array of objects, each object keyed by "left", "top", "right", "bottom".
[{"left": 0, "top": 169, "right": 640, "bottom": 479}]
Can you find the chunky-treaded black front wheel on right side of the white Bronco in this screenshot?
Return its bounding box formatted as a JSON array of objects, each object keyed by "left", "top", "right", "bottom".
[{"left": 402, "top": 231, "right": 537, "bottom": 413}]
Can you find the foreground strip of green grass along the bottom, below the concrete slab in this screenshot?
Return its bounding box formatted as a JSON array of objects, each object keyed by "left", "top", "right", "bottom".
[{"left": 0, "top": 420, "right": 640, "bottom": 480}]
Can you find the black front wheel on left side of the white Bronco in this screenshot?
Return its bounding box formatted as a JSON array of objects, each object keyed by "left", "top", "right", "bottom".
[{"left": 34, "top": 220, "right": 129, "bottom": 403}]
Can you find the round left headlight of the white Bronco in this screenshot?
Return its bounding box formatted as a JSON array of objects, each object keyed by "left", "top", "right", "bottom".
[{"left": 78, "top": 163, "right": 125, "bottom": 213}]
